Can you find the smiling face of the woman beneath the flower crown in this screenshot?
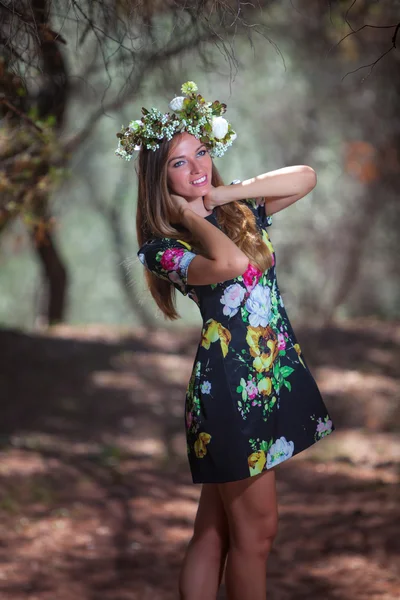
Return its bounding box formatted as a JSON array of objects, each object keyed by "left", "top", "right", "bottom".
[{"left": 167, "top": 131, "right": 212, "bottom": 201}]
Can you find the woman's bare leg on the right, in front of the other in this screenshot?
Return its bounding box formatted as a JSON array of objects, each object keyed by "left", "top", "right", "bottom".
[{"left": 218, "top": 469, "right": 278, "bottom": 600}]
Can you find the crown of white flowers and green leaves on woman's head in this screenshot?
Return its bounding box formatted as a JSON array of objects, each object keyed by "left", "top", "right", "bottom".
[{"left": 115, "top": 81, "right": 237, "bottom": 160}]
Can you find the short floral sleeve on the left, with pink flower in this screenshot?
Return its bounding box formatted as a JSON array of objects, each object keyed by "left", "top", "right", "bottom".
[{"left": 137, "top": 238, "right": 197, "bottom": 296}]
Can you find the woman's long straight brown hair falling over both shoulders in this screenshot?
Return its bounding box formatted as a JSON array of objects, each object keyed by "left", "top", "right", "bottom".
[{"left": 136, "top": 139, "right": 273, "bottom": 321}]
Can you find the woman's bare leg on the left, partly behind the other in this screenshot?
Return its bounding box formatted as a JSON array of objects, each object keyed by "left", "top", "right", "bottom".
[{"left": 179, "top": 483, "right": 229, "bottom": 600}]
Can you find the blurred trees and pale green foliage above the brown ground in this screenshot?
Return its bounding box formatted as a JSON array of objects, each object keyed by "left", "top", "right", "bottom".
[{"left": 0, "top": 0, "right": 400, "bottom": 328}]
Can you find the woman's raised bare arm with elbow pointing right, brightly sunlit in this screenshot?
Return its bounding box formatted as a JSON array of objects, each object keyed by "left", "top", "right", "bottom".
[{"left": 211, "top": 165, "right": 317, "bottom": 214}]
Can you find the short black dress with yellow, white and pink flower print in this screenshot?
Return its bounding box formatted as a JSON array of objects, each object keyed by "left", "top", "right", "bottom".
[{"left": 137, "top": 199, "right": 335, "bottom": 483}]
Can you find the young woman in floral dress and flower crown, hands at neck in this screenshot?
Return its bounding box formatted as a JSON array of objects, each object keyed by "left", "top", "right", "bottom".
[{"left": 117, "top": 82, "right": 334, "bottom": 600}]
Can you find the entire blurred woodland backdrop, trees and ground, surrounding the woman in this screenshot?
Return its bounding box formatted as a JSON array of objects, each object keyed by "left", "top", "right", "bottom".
[{"left": 0, "top": 5, "right": 400, "bottom": 600}]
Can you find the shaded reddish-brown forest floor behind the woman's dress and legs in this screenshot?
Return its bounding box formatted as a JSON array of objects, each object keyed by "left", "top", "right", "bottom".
[{"left": 0, "top": 320, "right": 400, "bottom": 600}]
